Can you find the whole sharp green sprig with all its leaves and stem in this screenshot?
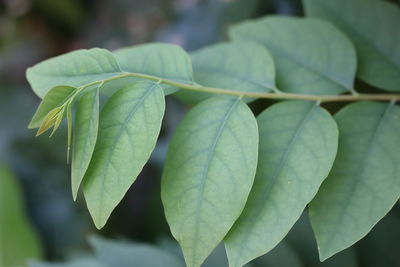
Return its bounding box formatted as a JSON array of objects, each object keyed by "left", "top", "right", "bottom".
[{"left": 27, "top": 0, "right": 400, "bottom": 267}]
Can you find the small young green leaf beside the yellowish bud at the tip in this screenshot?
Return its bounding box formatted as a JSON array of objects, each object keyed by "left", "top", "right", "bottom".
[{"left": 28, "top": 86, "right": 76, "bottom": 129}]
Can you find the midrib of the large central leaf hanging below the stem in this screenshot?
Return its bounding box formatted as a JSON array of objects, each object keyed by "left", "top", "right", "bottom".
[{"left": 192, "top": 97, "right": 241, "bottom": 263}]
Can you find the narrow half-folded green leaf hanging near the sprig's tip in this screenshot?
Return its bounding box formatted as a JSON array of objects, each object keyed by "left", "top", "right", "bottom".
[{"left": 71, "top": 88, "right": 99, "bottom": 200}]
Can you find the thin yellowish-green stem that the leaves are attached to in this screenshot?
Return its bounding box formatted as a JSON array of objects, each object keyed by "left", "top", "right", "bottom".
[{"left": 78, "top": 72, "right": 400, "bottom": 103}]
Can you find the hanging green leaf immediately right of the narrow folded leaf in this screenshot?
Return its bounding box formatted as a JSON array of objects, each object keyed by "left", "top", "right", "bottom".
[{"left": 83, "top": 82, "right": 165, "bottom": 228}]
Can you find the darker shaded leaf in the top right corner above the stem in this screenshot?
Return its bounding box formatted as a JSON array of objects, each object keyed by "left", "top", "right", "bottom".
[{"left": 304, "top": 0, "right": 400, "bottom": 91}]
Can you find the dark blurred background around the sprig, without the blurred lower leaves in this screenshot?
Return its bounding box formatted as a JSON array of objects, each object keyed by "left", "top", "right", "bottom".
[{"left": 0, "top": 0, "right": 400, "bottom": 267}]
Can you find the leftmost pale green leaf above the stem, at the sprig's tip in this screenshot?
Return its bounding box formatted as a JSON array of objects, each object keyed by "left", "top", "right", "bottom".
[{"left": 26, "top": 48, "right": 121, "bottom": 98}]
